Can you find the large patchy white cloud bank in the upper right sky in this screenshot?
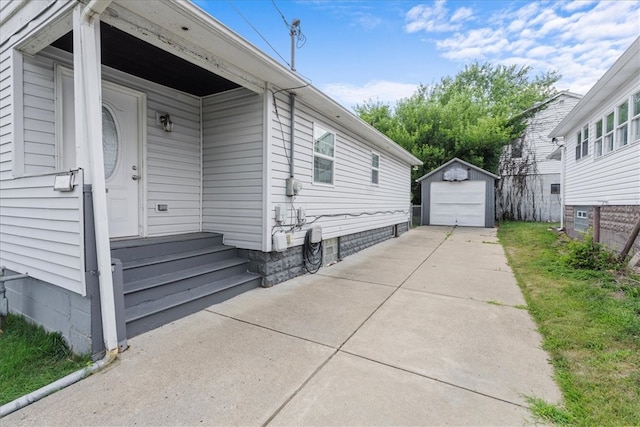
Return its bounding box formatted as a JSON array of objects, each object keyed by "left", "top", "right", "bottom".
[{"left": 405, "top": 0, "right": 640, "bottom": 93}]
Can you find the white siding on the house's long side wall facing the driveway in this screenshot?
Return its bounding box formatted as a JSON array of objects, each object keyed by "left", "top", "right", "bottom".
[{"left": 268, "top": 95, "right": 411, "bottom": 245}]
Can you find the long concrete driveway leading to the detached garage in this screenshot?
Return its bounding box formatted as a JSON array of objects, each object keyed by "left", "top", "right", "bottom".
[{"left": 7, "top": 227, "right": 561, "bottom": 427}]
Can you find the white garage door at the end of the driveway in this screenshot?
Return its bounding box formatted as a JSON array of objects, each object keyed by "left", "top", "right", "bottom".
[{"left": 429, "top": 181, "right": 486, "bottom": 227}]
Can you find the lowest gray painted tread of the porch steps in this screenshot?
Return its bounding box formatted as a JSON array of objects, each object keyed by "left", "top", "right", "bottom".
[{"left": 125, "top": 273, "right": 260, "bottom": 322}]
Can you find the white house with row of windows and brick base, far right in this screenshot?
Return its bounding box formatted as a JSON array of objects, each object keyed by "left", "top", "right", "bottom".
[{"left": 549, "top": 38, "right": 640, "bottom": 258}]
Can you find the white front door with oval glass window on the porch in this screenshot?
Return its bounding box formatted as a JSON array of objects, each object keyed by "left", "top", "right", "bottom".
[{"left": 102, "top": 85, "right": 140, "bottom": 237}]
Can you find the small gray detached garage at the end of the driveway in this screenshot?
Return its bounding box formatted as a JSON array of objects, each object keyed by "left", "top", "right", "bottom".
[{"left": 416, "top": 158, "right": 499, "bottom": 227}]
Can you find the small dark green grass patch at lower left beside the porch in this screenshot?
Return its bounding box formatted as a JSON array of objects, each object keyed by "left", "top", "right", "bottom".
[{"left": 0, "top": 315, "right": 90, "bottom": 405}]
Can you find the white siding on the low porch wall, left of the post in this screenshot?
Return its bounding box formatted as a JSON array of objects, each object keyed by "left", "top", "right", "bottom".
[{"left": 0, "top": 174, "right": 85, "bottom": 295}]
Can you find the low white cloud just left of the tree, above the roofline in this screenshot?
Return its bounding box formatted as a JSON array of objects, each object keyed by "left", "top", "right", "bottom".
[{"left": 320, "top": 80, "right": 418, "bottom": 108}]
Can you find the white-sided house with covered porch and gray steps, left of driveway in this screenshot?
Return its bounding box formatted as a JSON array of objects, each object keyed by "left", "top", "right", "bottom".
[{"left": 0, "top": 0, "right": 421, "bottom": 355}]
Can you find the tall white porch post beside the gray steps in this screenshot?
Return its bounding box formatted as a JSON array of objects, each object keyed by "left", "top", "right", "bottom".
[{"left": 73, "top": 2, "right": 118, "bottom": 354}]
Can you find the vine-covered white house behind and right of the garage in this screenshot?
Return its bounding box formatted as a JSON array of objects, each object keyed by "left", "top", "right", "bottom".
[{"left": 496, "top": 91, "right": 582, "bottom": 222}]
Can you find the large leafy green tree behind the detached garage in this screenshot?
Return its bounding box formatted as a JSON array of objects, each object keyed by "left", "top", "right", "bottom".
[{"left": 355, "top": 63, "right": 560, "bottom": 203}]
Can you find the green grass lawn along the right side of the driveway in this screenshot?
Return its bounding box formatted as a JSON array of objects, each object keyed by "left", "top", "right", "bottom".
[{"left": 498, "top": 223, "right": 640, "bottom": 426}]
